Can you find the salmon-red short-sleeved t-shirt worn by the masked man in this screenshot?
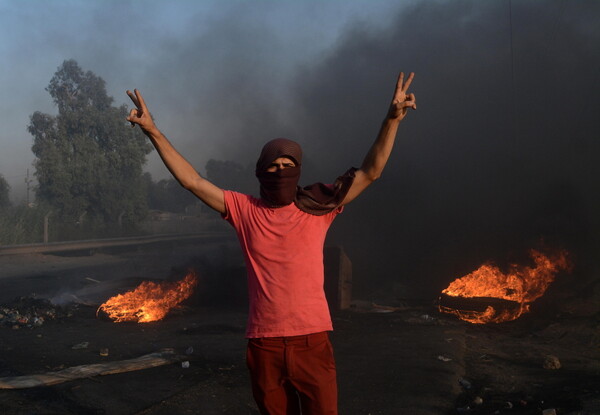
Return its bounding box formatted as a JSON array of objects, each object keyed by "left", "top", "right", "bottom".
[{"left": 224, "top": 191, "right": 342, "bottom": 338}]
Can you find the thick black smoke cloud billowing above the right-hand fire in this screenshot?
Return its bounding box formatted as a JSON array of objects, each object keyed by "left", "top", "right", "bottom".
[{"left": 282, "top": 1, "right": 600, "bottom": 296}]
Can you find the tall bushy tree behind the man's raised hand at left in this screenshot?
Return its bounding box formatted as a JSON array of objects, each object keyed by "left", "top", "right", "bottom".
[{"left": 28, "top": 60, "right": 151, "bottom": 231}]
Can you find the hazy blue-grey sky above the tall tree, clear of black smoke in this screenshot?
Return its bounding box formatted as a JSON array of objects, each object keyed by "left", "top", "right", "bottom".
[{"left": 0, "top": 0, "right": 404, "bottom": 201}]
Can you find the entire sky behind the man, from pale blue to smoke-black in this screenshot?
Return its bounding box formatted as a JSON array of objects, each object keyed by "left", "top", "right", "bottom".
[{"left": 0, "top": 0, "right": 600, "bottom": 298}]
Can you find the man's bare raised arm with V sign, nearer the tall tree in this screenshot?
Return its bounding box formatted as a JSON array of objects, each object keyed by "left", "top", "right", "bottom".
[{"left": 127, "top": 89, "right": 225, "bottom": 214}]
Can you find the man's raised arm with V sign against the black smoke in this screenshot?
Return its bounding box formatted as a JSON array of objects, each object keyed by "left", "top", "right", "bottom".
[{"left": 342, "top": 72, "right": 417, "bottom": 205}]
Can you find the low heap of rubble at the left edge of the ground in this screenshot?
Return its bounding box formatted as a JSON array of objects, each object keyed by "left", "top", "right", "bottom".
[{"left": 0, "top": 297, "right": 77, "bottom": 329}]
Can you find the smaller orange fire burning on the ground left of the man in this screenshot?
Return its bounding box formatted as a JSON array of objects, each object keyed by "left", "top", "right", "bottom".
[{"left": 96, "top": 272, "right": 198, "bottom": 323}]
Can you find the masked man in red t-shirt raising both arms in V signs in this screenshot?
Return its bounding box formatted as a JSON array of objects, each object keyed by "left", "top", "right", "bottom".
[{"left": 127, "top": 73, "right": 417, "bottom": 415}]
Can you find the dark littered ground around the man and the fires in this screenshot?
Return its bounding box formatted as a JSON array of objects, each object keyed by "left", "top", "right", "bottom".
[{"left": 0, "top": 246, "right": 600, "bottom": 415}]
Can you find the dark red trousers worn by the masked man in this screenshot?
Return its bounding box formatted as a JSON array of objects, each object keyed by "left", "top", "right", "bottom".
[{"left": 246, "top": 332, "right": 338, "bottom": 415}]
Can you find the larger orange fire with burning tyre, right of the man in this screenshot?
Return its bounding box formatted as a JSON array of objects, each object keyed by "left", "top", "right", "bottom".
[{"left": 439, "top": 249, "right": 569, "bottom": 324}]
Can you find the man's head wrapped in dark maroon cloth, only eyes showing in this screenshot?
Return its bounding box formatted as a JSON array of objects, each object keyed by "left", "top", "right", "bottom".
[{"left": 256, "top": 138, "right": 302, "bottom": 207}]
